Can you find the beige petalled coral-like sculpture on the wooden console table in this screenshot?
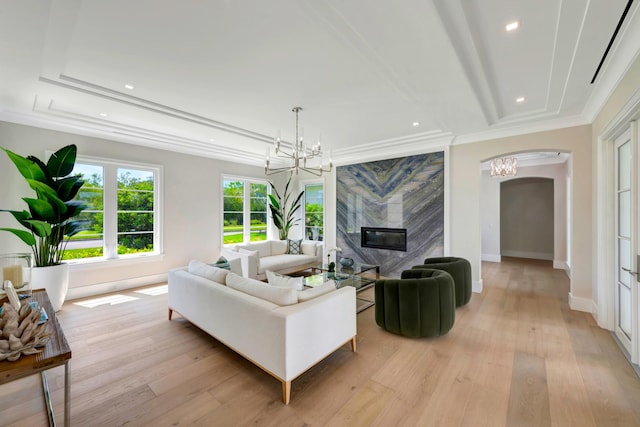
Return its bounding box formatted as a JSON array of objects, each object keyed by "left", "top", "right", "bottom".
[{"left": 0, "top": 303, "right": 51, "bottom": 362}]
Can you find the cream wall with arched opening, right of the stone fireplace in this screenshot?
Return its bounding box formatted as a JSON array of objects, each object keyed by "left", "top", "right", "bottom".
[{"left": 450, "top": 125, "right": 592, "bottom": 307}]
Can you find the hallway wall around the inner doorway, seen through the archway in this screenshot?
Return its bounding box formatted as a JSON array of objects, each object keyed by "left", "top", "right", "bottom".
[{"left": 480, "top": 163, "right": 568, "bottom": 269}]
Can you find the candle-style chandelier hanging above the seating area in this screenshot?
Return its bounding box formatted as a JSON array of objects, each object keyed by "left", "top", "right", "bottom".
[{"left": 264, "top": 107, "right": 333, "bottom": 176}]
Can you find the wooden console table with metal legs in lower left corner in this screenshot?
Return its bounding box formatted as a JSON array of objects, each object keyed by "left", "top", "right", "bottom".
[{"left": 0, "top": 289, "right": 71, "bottom": 426}]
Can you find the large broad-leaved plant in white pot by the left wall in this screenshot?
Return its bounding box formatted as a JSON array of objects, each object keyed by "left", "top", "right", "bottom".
[{"left": 0, "top": 145, "right": 86, "bottom": 311}]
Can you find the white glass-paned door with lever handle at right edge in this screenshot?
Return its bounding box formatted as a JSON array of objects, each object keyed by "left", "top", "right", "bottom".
[{"left": 615, "top": 130, "right": 639, "bottom": 363}]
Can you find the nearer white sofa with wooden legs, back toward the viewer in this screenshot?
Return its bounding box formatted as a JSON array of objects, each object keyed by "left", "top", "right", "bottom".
[{"left": 168, "top": 264, "right": 356, "bottom": 404}]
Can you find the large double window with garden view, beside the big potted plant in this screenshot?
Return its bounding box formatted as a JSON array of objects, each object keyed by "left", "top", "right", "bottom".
[{"left": 64, "top": 157, "right": 161, "bottom": 260}]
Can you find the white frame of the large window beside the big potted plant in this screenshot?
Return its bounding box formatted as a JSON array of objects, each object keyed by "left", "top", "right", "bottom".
[{"left": 65, "top": 152, "right": 164, "bottom": 264}]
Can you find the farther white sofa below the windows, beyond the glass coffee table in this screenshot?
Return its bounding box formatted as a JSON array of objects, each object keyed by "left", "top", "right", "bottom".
[{"left": 222, "top": 240, "right": 322, "bottom": 280}]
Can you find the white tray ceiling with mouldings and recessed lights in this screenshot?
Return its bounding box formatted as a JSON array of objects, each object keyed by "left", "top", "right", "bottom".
[{"left": 0, "top": 0, "right": 640, "bottom": 165}]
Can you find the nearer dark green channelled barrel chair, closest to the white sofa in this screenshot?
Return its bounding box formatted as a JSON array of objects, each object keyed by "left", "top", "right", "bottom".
[{"left": 375, "top": 269, "right": 456, "bottom": 338}]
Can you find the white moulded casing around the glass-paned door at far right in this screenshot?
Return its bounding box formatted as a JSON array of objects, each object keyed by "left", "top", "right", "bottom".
[{"left": 593, "top": 90, "right": 640, "bottom": 364}]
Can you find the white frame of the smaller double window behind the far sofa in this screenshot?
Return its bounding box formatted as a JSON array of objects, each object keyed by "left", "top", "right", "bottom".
[{"left": 220, "top": 174, "right": 273, "bottom": 247}]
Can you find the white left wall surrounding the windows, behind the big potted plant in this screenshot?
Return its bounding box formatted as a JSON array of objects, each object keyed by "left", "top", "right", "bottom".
[{"left": 0, "top": 122, "right": 264, "bottom": 296}]
